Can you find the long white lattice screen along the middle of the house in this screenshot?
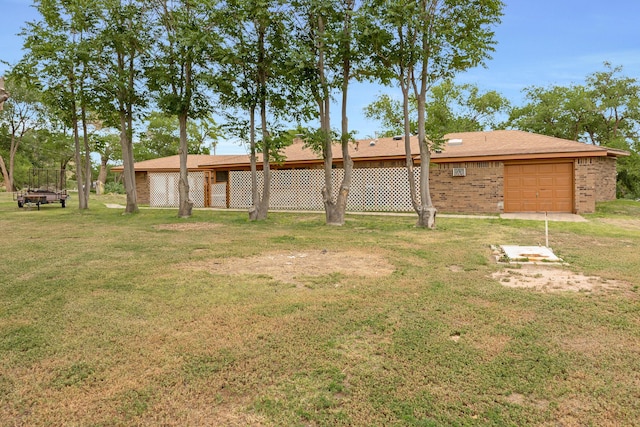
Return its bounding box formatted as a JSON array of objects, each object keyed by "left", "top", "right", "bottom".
[{"left": 229, "top": 168, "right": 420, "bottom": 212}]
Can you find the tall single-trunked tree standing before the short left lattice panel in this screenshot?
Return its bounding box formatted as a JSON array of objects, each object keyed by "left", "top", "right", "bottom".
[{"left": 146, "top": 0, "right": 219, "bottom": 218}]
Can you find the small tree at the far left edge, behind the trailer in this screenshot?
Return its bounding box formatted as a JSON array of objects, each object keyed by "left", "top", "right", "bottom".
[{"left": 0, "top": 76, "right": 42, "bottom": 191}]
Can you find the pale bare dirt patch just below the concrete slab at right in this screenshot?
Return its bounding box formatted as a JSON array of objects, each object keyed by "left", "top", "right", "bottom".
[{"left": 491, "top": 264, "right": 631, "bottom": 293}]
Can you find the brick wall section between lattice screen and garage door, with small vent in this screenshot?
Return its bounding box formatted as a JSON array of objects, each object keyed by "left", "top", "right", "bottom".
[{"left": 429, "top": 162, "right": 504, "bottom": 214}]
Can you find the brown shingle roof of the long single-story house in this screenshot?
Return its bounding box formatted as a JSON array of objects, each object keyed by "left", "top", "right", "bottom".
[{"left": 114, "top": 130, "right": 629, "bottom": 171}]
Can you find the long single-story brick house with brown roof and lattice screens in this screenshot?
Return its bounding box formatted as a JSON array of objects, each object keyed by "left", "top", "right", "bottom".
[{"left": 114, "top": 130, "right": 628, "bottom": 214}]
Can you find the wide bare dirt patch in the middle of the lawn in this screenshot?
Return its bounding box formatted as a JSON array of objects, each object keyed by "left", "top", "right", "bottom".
[{"left": 181, "top": 250, "right": 395, "bottom": 284}]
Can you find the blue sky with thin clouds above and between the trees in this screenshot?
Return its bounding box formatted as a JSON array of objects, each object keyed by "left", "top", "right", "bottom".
[{"left": 0, "top": 0, "right": 640, "bottom": 154}]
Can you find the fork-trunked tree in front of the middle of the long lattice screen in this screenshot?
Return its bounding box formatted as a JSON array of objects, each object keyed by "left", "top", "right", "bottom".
[{"left": 294, "top": 0, "right": 368, "bottom": 225}]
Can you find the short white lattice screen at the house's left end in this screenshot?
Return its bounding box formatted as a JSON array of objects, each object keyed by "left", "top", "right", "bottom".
[{"left": 149, "top": 172, "right": 204, "bottom": 208}]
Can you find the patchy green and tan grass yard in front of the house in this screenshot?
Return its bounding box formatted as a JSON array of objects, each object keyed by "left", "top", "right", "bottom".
[{"left": 0, "top": 193, "right": 640, "bottom": 426}]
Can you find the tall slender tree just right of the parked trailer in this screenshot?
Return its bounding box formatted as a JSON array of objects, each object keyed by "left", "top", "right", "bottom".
[{"left": 16, "top": 0, "right": 101, "bottom": 209}]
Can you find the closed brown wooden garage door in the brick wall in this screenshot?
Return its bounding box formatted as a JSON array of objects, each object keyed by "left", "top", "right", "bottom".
[{"left": 504, "top": 162, "right": 573, "bottom": 212}]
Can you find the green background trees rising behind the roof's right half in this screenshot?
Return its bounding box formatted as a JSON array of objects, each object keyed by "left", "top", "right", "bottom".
[{"left": 365, "top": 63, "right": 640, "bottom": 199}]
